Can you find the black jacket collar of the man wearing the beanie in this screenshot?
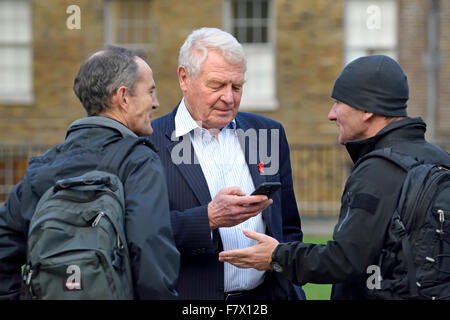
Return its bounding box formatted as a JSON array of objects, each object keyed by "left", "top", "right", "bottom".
[{"left": 345, "top": 117, "right": 426, "bottom": 163}]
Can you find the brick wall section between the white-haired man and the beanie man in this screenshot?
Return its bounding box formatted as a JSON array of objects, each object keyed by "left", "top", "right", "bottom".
[{"left": 265, "top": 0, "right": 343, "bottom": 143}]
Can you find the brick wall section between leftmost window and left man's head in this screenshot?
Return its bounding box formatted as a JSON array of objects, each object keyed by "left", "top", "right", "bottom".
[{"left": 0, "top": 0, "right": 103, "bottom": 144}]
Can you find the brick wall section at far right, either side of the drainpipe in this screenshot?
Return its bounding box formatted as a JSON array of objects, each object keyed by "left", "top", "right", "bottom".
[{"left": 398, "top": 0, "right": 450, "bottom": 142}]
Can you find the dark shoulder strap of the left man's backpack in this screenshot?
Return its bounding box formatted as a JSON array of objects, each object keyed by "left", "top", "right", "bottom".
[{"left": 97, "top": 137, "right": 156, "bottom": 174}]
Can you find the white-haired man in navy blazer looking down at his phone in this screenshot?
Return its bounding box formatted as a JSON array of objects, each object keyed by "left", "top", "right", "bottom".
[{"left": 150, "top": 28, "right": 304, "bottom": 300}]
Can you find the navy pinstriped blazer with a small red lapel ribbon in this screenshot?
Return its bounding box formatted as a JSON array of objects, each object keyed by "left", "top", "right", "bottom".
[{"left": 150, "top": 107, "right": 304, "bottom": 300}]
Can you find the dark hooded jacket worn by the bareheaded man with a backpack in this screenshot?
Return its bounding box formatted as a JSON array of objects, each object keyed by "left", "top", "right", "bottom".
[{"left": 0, "top": 117, "right": 180, "bottom": 299}]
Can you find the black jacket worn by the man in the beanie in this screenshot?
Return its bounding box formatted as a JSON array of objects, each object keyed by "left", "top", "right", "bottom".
[{"left": 274, "top": 118, "right": 450, "bottom": 299}]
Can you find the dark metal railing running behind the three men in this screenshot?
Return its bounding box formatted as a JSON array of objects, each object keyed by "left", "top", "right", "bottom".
[{"left": 0, "top": 144, "right": 450, "bottom": 217}]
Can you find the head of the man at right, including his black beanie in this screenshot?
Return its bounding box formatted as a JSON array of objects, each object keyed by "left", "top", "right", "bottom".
[{"left": 328, "top": 55, "right": 409, "bottom": 148}]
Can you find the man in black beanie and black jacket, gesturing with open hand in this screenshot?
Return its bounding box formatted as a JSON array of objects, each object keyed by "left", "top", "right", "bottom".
[{"left": 219, "top": 55, "right": 450, "bottom": 300}]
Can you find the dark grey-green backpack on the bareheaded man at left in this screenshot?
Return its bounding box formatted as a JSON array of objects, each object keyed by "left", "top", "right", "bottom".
[{"left": 21, "top": 138, "right": 151, "bottom": 300}]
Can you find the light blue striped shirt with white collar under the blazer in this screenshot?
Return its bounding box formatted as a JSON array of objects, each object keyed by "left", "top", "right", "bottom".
[{"left": 175, "top": 99, "right": 266, "bottom": 292}]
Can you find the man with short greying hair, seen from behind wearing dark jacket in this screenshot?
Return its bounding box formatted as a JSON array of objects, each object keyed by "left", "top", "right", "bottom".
[{"left": 0, "top": 46, "right": 179, "bottom": 299}]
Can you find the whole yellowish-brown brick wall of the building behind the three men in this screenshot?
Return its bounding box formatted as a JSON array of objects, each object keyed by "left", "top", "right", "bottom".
[{"left": 0, "top": 0, "right": 450, "bottom": 144}]
